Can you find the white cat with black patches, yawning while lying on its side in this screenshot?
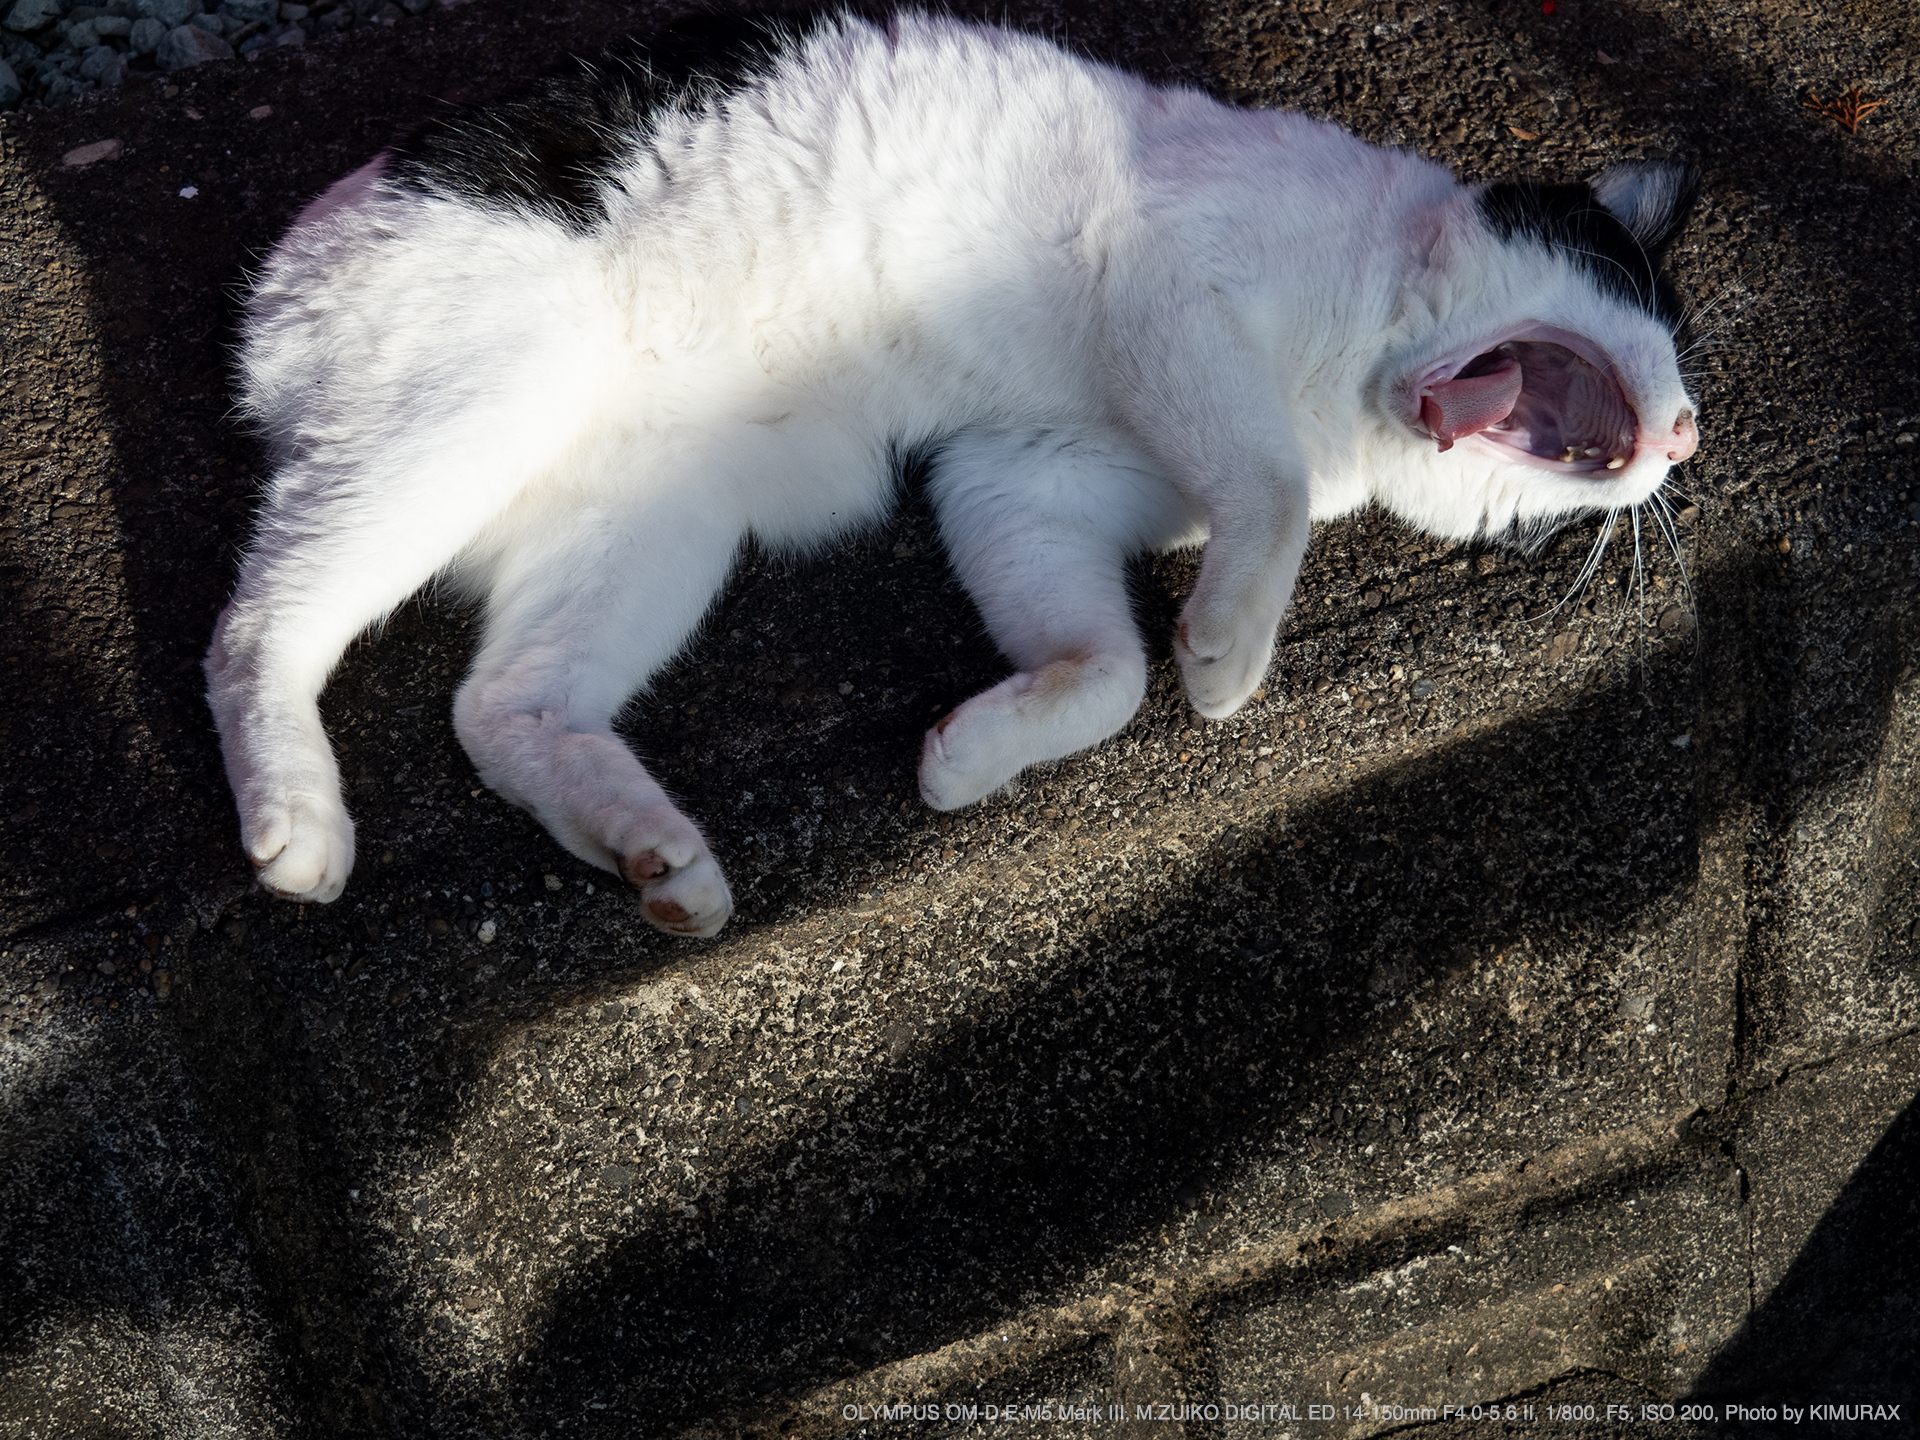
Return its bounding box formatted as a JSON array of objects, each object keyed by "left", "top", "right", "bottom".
[{"left": 205, "top": 15, "right": 1695, "bottom": 935}]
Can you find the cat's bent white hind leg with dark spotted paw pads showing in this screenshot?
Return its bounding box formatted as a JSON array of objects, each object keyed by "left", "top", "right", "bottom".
[{"left": 453, "top": 488, "right": 745, "bottom": 935}]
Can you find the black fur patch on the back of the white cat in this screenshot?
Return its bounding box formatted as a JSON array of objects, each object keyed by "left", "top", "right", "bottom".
[{"left": 386, "top": 13, "right": 837, "bottom": 230}]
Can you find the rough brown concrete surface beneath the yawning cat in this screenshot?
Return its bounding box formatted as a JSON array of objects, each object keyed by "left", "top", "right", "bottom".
[{"left": 0, "top": 0, "right": 1920, "bottom": 1436}]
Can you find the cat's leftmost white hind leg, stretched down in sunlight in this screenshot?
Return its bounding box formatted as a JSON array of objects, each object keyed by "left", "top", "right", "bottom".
[{"left": 205, "top": 461, "right": 513, "bottom": 900}]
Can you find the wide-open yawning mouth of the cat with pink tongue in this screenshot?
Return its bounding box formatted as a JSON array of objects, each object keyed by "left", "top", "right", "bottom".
[{"left": 1413, "top": 328, "right": 1640, "bottom": 476}]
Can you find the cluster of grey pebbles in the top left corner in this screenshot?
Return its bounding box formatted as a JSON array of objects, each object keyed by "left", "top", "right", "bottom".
[{"left": 0, "top": 0, "right": 447, "bottom": 109}]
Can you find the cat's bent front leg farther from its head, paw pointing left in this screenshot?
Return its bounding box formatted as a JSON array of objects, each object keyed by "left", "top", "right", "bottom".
[{"left": 920, "top": 432, "right": 1190, "bottom": 810}]
